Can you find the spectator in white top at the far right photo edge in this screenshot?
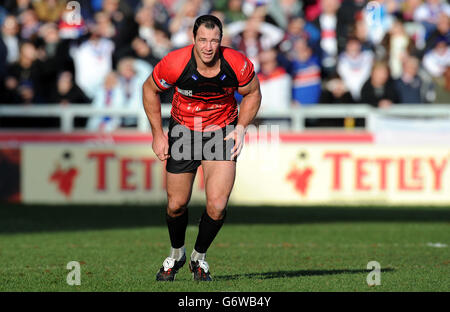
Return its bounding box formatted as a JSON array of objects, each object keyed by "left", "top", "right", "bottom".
[{"left": 423, "top": 39, "right": 450, "bottom": 77}]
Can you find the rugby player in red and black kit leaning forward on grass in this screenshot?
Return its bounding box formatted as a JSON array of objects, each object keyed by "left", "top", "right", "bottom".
[{"left": 143, "top": 15, "right": 261, "bottom": 281}]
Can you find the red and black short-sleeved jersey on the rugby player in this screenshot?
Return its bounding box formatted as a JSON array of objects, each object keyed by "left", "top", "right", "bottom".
[{"left": 152, "top": 45, "right": 255, "bottom": 131}]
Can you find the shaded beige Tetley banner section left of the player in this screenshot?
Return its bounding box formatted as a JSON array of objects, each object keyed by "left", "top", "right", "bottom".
[{"left": 21, "top": 144, "right": 204, "bottom": 203}]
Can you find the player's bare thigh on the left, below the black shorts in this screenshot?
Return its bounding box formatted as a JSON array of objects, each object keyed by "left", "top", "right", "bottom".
[{"left": 166, "top": 172, "right": 195, "bottom": 209}]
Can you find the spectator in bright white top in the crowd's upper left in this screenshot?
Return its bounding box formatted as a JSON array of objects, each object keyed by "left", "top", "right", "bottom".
[{"left": 70, "top": 26, "right": 114, "bottom": 98}]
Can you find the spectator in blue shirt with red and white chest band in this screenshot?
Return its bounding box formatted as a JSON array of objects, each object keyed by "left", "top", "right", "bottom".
[{"left": 292, "top": 40, "right": 321, "bottom": 106}]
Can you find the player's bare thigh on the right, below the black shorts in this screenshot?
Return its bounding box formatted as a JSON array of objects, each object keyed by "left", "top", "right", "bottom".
[{"left": 202, "top": 160, "right": 236, "bottom": 204}]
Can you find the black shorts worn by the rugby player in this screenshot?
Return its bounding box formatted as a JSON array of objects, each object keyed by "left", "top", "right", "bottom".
[{"left": 166, "top": 118, "right": 237, "bottom": 173}]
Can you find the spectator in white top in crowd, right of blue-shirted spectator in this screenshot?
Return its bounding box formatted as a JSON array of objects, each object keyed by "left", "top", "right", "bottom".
[{"left": 337, "top": 37, "right": 373, "bottom": 101}]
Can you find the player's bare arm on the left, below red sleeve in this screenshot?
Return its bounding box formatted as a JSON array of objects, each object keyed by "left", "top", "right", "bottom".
[{"left": 142, "top": 76, "right": 170, "bottom": 161}]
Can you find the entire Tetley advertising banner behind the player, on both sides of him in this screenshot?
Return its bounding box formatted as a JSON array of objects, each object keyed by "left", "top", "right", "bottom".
[{"left": 21, "top": 142, "right": 450, "bottom": 205}]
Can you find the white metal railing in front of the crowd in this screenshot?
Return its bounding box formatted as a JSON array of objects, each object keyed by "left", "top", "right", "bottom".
[{"left": 0, "top": 104, "right": 450, "bottom": 133}]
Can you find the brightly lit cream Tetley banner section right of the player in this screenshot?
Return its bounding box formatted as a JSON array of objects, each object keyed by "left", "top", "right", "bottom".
[{"left": 232, "top": 143, "right": 450, "bottom": 205}]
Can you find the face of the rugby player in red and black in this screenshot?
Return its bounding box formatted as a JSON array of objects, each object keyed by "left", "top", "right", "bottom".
[{"left": 194, "top": 25, "right": 220, "bottom": 64}]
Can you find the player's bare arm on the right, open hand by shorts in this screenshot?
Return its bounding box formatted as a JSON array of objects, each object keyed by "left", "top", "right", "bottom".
[{"left": 225, "top": 75, "right": 262, "bottom": 160}]
